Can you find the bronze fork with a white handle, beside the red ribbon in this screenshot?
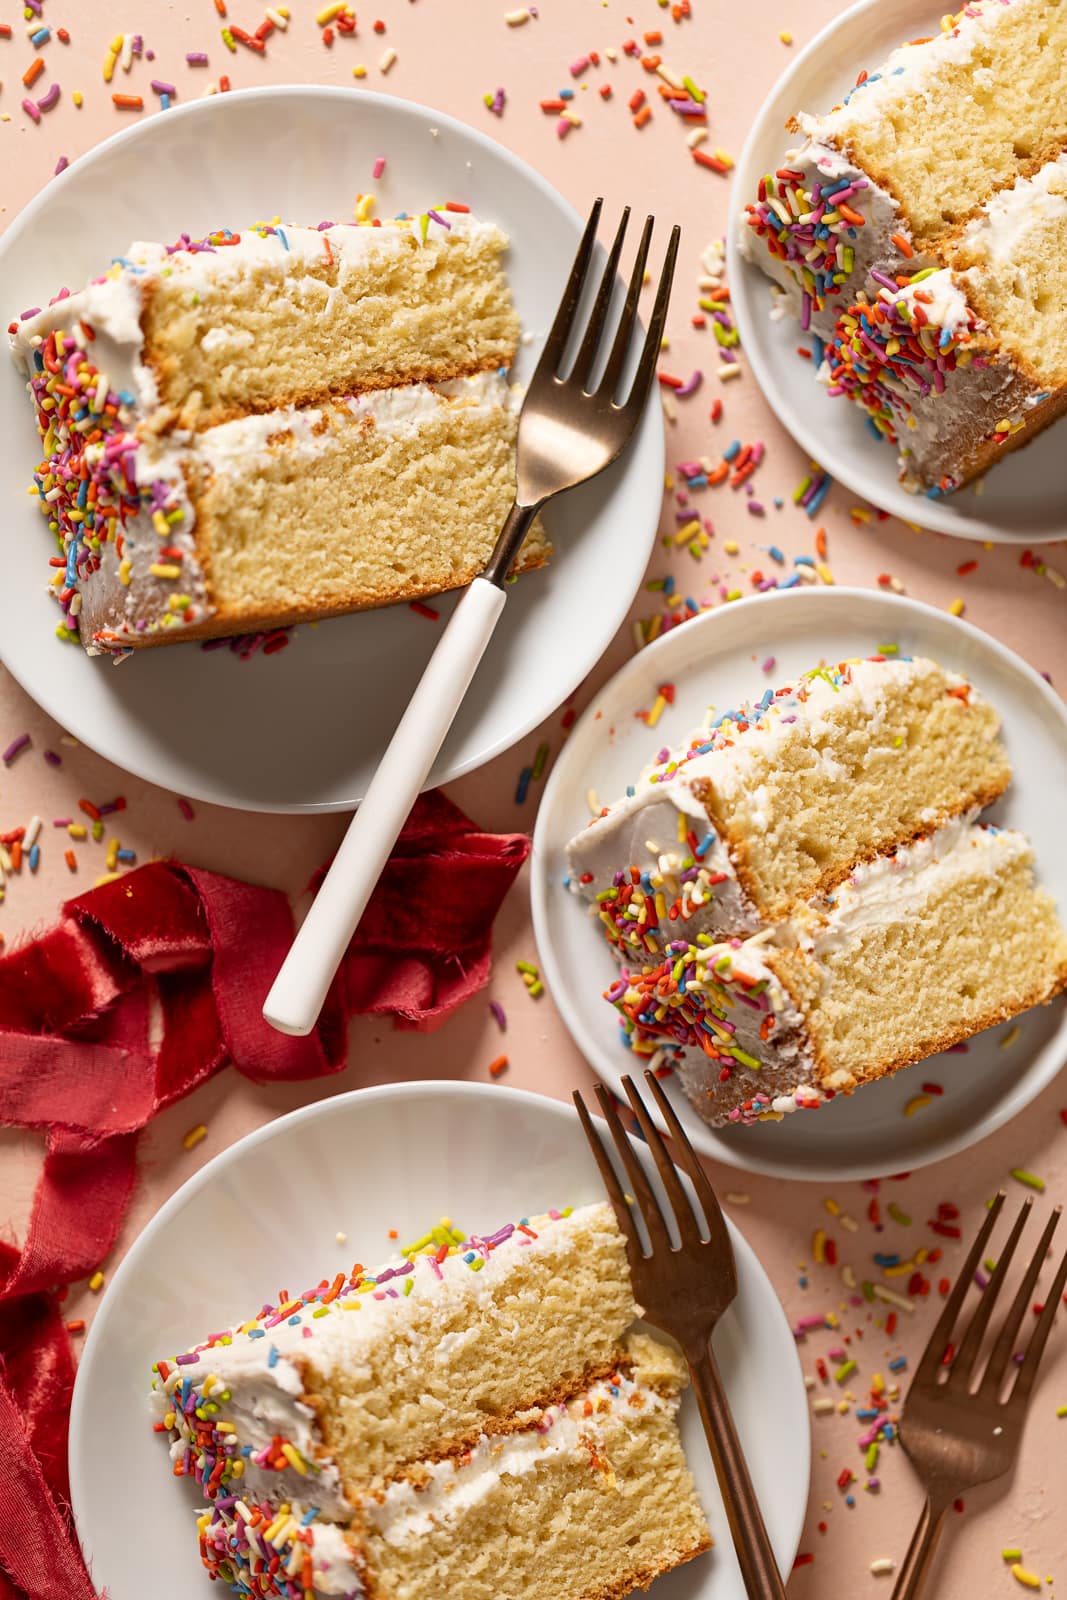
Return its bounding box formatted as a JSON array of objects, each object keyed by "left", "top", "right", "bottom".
[{"left": 262, "top": 200, "right": 680, "bottom": 1034}]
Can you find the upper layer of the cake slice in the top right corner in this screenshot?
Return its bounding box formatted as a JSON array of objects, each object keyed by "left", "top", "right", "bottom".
[{"left": 742, "top": 0, "right": 1067, "bottom": 339}]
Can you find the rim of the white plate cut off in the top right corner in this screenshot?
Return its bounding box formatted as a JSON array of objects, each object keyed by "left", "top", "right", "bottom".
[{"left": 726, "top": 0, "right": 1067, "bottom": 546}]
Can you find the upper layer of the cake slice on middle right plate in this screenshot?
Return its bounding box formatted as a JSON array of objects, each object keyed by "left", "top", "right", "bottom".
[{"left": 568, "top": 656, "right": 1011, "bottom": 960}]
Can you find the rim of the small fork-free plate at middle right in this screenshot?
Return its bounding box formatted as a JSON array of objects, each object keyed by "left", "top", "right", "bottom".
[{"left": 530, "top": 582, "right": 1067, "bottom": 1184}]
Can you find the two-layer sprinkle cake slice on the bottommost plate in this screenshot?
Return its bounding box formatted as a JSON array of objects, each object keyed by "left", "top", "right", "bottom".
[{"left": 154, "top": 1205, "right": 710, "bottom": 1600}]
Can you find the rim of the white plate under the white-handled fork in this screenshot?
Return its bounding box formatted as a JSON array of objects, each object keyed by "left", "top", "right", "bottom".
[{"left": 0, "top": 83, "right": 667, "bottom": 816}]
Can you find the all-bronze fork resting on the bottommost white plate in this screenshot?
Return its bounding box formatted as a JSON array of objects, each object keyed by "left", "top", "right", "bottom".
[{"left": 574, "top": 1072, "right": 785, "bottom": 1600}]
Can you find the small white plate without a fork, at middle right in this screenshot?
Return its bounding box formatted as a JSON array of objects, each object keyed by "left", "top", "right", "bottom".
[{"left": 530, "top": 589, "right": 1067, "bottom": 1181}]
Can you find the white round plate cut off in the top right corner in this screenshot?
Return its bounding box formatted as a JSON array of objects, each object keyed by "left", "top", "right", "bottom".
[{"left": 726, "top": 0, "right": 1067, "bottom": 544}]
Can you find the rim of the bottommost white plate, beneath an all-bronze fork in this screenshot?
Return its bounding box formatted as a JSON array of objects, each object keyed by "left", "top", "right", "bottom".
[{"left": 67, "top": 1078, "right": 811, "bottom": 1576}]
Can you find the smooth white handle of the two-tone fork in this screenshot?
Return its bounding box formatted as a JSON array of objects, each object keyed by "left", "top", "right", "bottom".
[{"left": 262, "top": 576, "right": 508, "bottom": 1035}]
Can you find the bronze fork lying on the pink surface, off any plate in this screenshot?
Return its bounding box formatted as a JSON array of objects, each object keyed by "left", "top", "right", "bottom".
[{"left": 893, "top": 1194, "right": 1067, "bottom": 1600}]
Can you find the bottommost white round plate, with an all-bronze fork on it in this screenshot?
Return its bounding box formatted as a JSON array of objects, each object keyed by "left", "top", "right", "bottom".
[{"left": 70, "top": 1083, "right": 809, "bottom": 1600}]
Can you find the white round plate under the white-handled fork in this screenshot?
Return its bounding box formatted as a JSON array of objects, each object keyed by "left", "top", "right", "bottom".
[{"left": 0, "top": 88, "right": 664, "bottom": 811}]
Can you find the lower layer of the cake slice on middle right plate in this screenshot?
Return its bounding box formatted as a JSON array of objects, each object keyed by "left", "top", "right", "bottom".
[{"left": 606, "top": 819, "right": 1067, "bottom": 1125}]
